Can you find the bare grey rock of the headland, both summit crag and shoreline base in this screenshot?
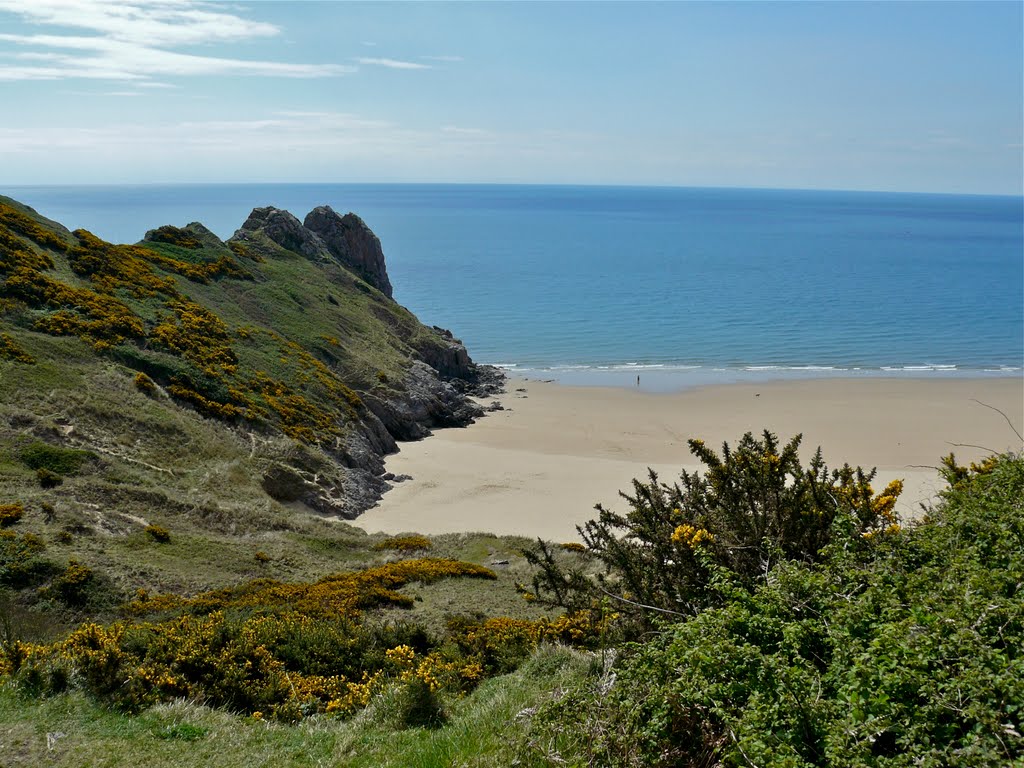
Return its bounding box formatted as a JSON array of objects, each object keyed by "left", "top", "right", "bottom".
[{"left": 205, "top": 201, "right": 505, "bottom": 519}]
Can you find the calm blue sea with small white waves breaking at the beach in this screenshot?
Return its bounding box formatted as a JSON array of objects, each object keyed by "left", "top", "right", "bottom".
[{"left": 0, "top": 184, "right": 1024, "bottom": 390}]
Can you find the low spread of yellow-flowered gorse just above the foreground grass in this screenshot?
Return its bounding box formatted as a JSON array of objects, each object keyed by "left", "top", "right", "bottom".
[{"left": 0, "top": 559, "right": 588, "bottom": 725}]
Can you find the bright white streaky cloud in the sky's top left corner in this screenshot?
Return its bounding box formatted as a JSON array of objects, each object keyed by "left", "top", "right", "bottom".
[{"left": 0, "top": 0, "right": 353, "bottom": 85}]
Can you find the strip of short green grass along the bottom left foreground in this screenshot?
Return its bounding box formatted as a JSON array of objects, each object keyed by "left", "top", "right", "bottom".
[{"left": 0, "top": 647, "right": 599, "bottom": 768}]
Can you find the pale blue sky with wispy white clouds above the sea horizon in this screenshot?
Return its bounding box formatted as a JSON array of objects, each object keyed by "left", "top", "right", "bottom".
[{"left": 0, "top": 0, "right": 1024, "bottom": 195}]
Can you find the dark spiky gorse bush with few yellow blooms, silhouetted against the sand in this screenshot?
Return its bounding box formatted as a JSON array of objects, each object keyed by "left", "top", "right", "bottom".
[{"left": 525, "top": 431, "right": 902, "bottom": 625}]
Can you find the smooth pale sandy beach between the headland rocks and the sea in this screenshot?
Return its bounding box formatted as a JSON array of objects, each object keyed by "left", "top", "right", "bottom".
[{"left": 356, "top": 378, "right": 1024, "bottom": 541}]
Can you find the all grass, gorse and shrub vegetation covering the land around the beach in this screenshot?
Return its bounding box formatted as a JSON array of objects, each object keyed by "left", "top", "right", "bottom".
[{"left": 0, "top": 201, "right": 1024, "bottom": 768}]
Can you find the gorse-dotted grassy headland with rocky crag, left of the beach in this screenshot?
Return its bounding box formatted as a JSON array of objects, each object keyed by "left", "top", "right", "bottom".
[{"left": 0, "top": 198, "right": 501, "bottom": 518}]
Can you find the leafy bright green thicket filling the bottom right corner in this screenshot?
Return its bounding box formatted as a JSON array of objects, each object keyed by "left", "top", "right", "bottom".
[{"left": 526, "top": 457, "right": 1024, "bottom": 768}]
